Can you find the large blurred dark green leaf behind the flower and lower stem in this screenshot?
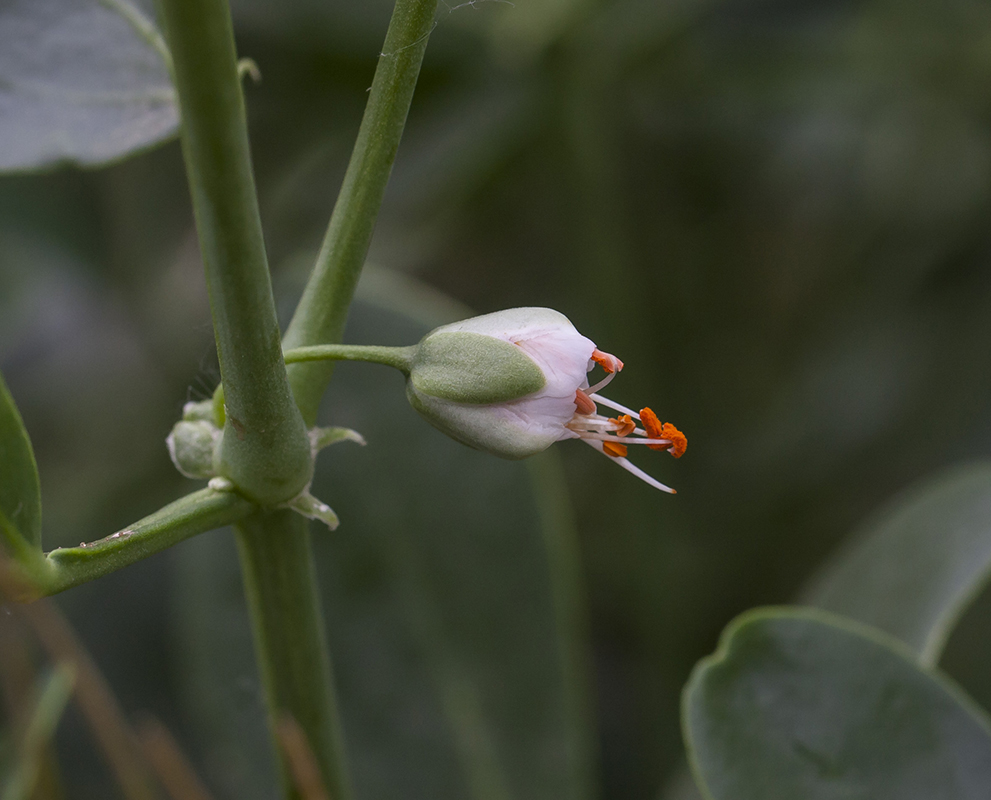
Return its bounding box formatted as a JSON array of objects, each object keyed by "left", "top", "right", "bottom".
[{"left": 175, "top": 287, "right": 592, "bottom": 800}]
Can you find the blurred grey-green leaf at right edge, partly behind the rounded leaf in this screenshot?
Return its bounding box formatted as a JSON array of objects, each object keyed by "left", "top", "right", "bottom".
[{"left": 803, "top": 463, "right": 991, "bottom": 666}]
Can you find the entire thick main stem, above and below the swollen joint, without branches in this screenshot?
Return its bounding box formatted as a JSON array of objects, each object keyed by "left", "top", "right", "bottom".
[{"left": 160, "top": 0, "right": 350, "bottom": 800}]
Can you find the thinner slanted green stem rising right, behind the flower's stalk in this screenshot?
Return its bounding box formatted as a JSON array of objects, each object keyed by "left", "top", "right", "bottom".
[{"left": 283, "top": 0, "right": 437, "bottom": 425}]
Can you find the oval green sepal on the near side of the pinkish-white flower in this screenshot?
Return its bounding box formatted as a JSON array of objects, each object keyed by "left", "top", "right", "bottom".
[{"left": 410, "top": 331, "right": 547, "bottom": 405}]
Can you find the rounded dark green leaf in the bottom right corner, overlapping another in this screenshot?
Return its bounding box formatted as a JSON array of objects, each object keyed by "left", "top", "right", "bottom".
[{"left": 683, "top": 608, "right": 991, "bottom": 800}]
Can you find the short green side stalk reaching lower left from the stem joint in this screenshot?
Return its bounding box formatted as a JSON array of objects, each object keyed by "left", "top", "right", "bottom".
[{"left": 41, "top": 489, "right": 255, "bottom": 594}]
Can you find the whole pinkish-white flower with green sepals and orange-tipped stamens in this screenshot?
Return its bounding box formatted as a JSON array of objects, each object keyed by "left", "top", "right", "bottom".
[{"left": 407, "top": 308, "right": 687, "bottom": 493}]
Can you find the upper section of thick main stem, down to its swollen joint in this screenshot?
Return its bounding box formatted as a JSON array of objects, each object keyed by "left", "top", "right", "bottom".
[{"left": 160, "top": 0, "right": 313, "bottom": 505}]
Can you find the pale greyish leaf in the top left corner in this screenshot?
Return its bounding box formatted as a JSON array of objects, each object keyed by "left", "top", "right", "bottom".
[{"left": 0, "top": 0, "right": 179, "bottom": 172}]
